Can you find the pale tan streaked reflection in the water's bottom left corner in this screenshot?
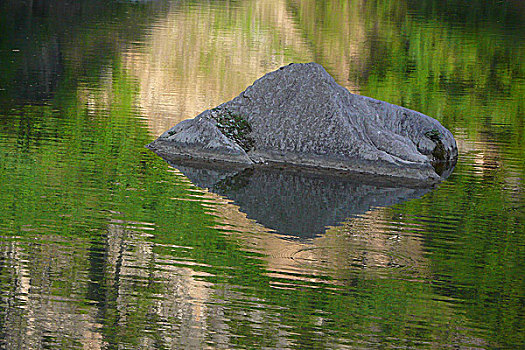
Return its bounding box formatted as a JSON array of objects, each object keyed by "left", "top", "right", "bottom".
[{"left": 0, "top": 235, "right": 105, "bottom": 350}]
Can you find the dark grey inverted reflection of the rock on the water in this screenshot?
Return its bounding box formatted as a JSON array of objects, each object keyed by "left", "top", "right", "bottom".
[{"left": 162, "top": 159, "right": 431, "bottom": 238}]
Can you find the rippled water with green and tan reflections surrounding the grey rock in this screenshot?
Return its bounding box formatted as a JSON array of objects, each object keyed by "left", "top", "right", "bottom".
[{"left": 0, "top": 0, "right": 525, "bottom": 349}]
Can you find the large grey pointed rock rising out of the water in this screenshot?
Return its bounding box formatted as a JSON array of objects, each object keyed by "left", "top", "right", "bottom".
[{"left": 148, "top": 63, "right": 457, "bottom": 182}]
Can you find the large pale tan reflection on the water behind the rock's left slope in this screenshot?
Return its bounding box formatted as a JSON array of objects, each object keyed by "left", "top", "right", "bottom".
[{"left": 124, "top": 0, "right": 313, "bottom": 135}]
